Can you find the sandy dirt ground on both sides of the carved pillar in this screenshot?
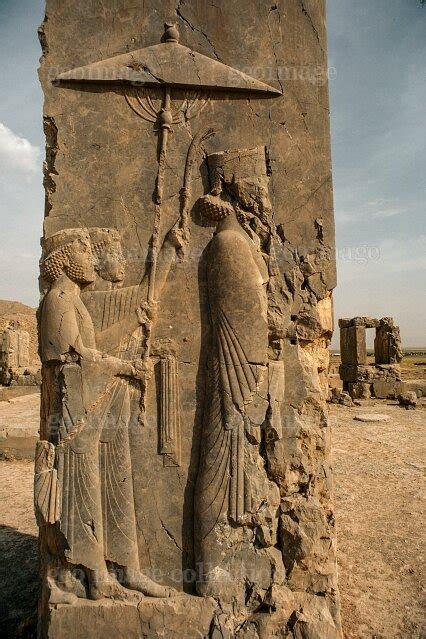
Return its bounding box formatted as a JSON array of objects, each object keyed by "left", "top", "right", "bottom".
[{"left": 0, "top": 401, "right": 426, "bottom": 639}]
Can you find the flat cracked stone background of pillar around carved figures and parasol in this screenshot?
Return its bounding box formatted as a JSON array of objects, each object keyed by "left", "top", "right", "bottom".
[{"left": 40, "top": 0, "right": 340, "bottom": 638}]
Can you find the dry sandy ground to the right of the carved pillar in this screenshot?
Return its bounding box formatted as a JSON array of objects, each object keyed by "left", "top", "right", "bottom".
[{"left": 331, "top": 400, "right": 426, "bottom": 639}]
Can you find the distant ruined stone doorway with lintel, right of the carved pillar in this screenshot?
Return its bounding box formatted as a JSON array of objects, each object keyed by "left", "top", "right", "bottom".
[{"left": 339, "top": 317, "right": 402, "bottom": 399}]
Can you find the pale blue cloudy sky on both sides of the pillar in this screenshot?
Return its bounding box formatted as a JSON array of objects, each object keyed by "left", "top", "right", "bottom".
[{"left": 0, "top": 0, "right": 426, "bottom": 346}]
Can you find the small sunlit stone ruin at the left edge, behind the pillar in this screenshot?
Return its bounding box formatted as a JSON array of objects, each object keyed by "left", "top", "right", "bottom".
[{"left": 0, "top": 320, "right": 41, "bottom": 386}]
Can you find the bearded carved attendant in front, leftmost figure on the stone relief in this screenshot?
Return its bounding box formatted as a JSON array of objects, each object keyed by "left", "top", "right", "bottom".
[{"left": 35, "top": 228, "right": 171, "bottom": 603}]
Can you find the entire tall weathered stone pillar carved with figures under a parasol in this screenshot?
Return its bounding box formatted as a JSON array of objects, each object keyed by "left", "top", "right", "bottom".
[{"left": 34, "top": 0, "right": 342, "bottom": 639}]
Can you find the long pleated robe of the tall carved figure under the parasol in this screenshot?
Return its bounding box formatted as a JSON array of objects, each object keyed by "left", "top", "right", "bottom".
[{"left": 195, "top": 223, "right": 268, "bottom": 584}]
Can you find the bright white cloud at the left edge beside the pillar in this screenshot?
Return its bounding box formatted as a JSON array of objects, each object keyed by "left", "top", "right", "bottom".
[{"left": 0, "top": 122, "right": 40, "bottom": 174}]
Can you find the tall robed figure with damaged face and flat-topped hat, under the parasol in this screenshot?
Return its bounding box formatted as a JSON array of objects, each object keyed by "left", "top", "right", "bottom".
[{"left": 195, "top": 149, "right": 280, "bottom": 595}]
